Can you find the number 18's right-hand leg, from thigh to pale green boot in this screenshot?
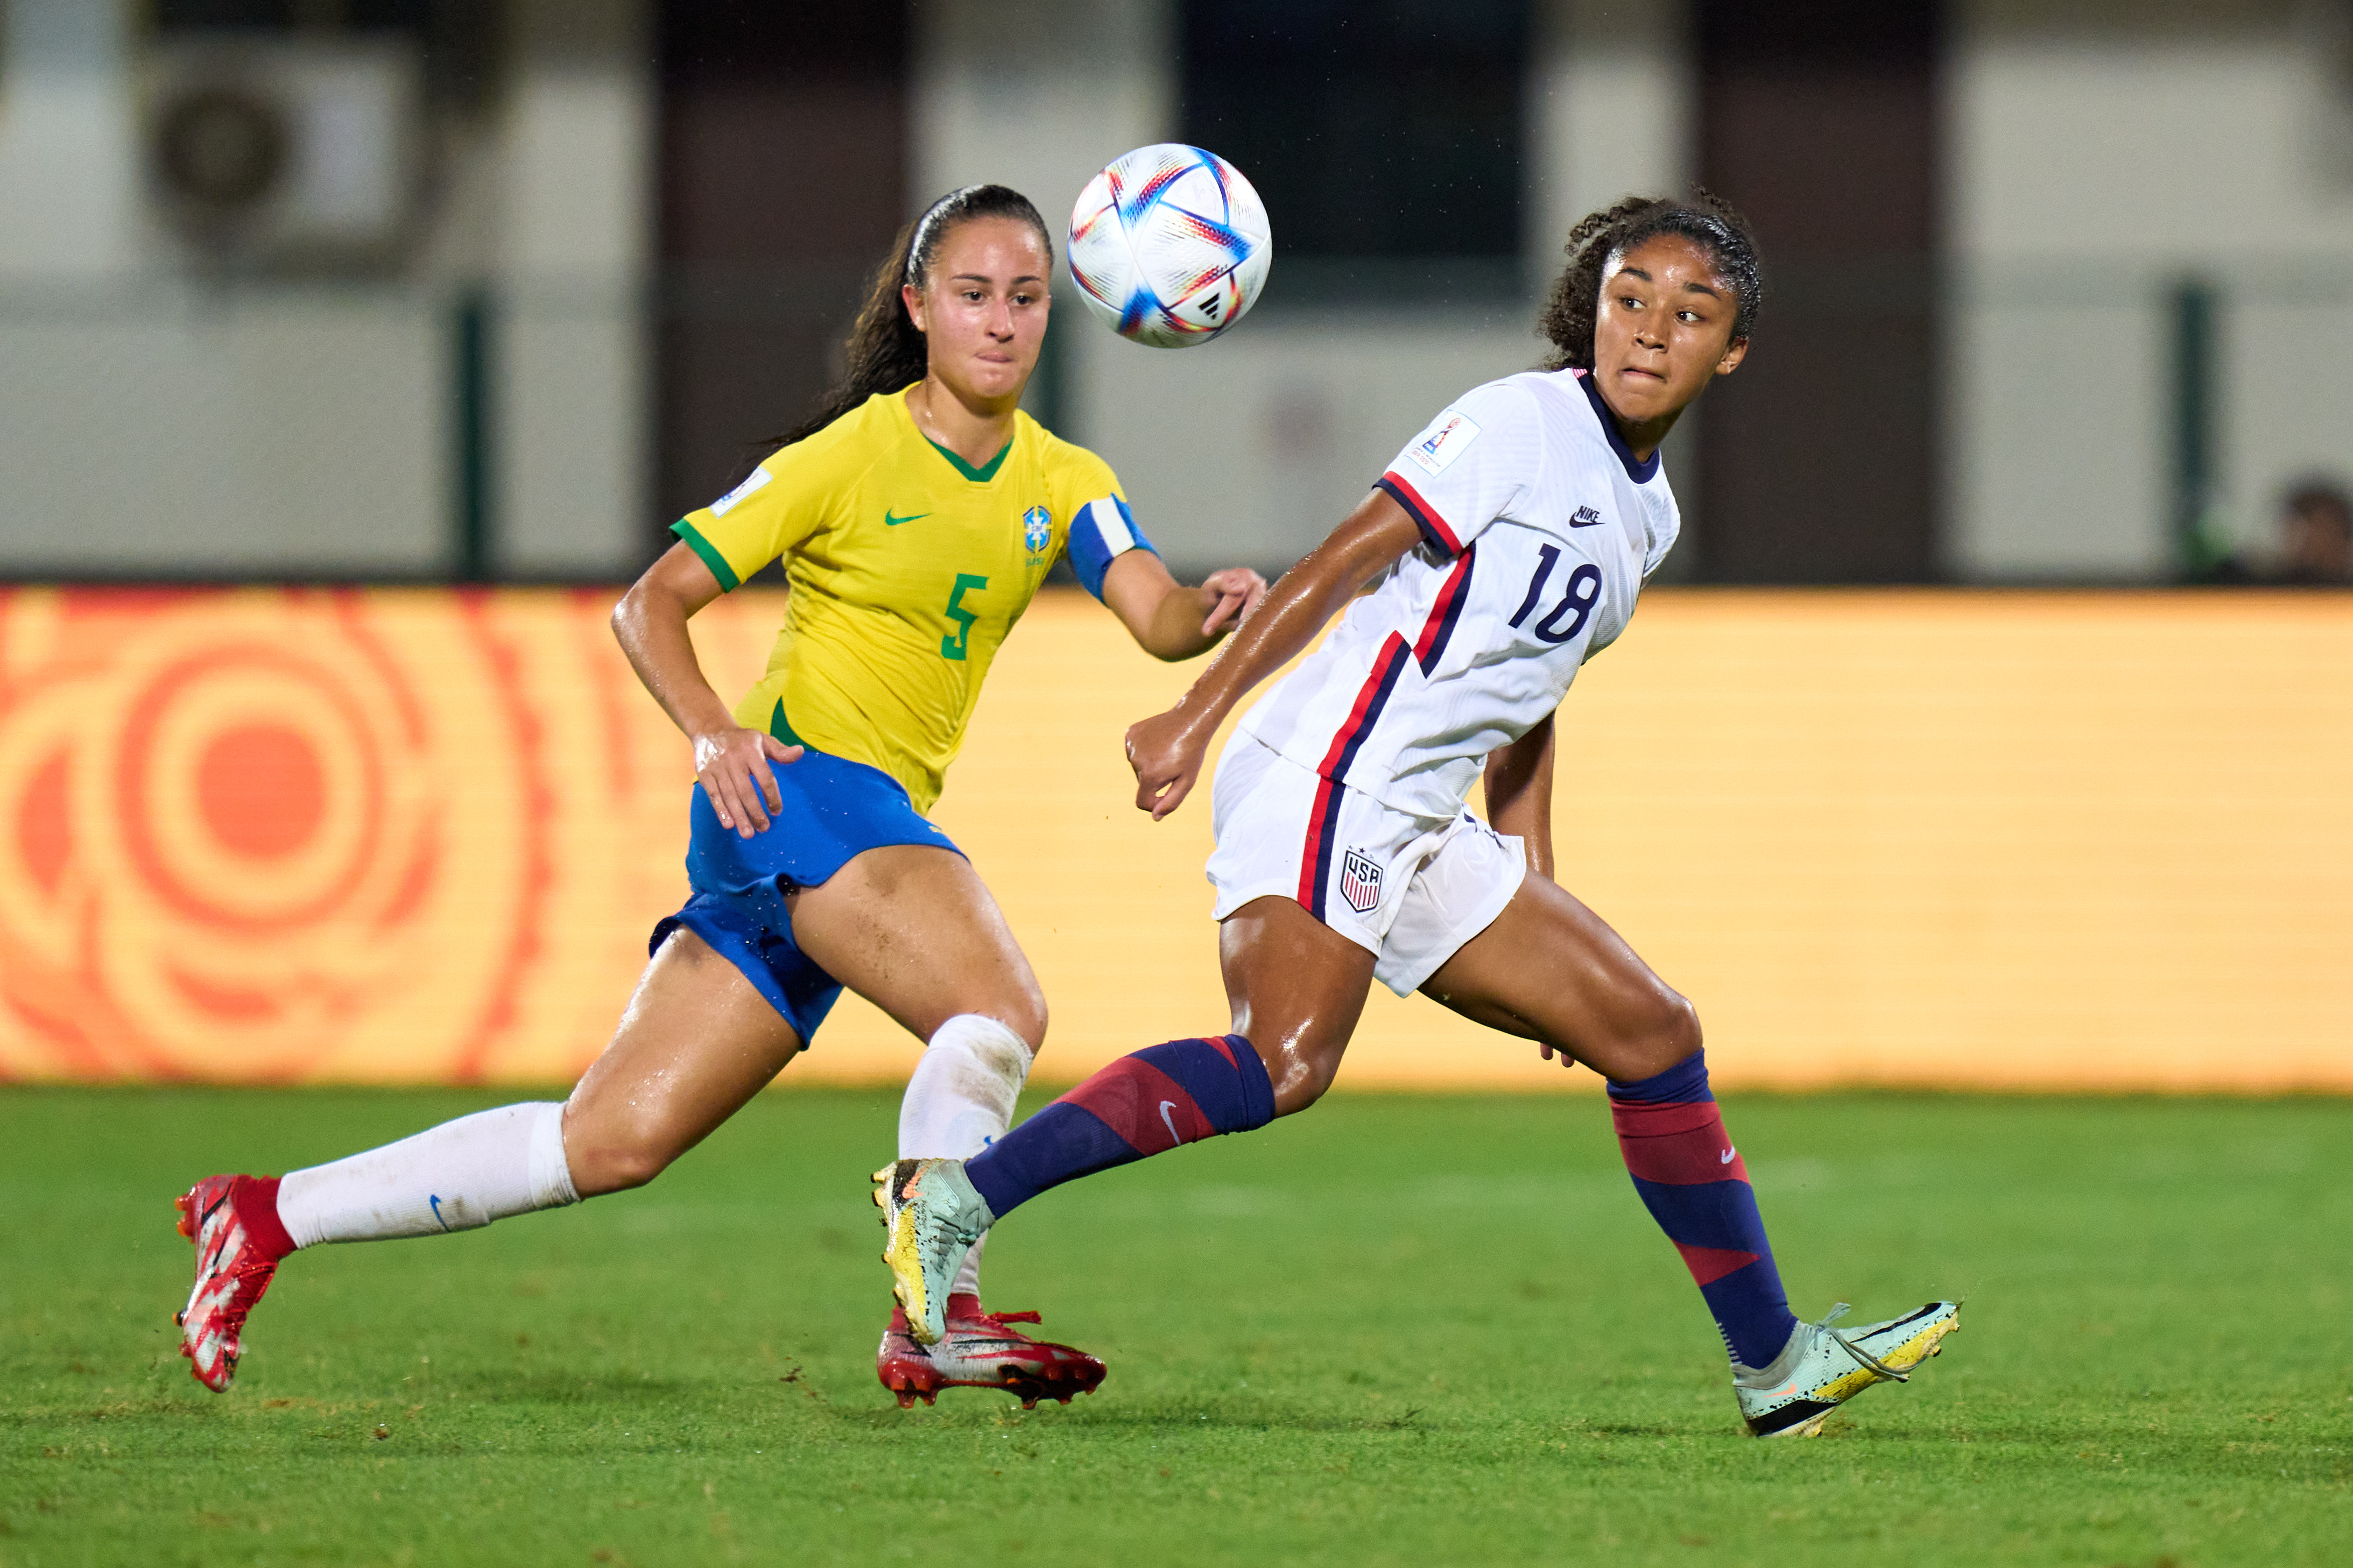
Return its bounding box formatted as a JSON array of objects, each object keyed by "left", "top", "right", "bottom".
[{"left": 1421, "top": 874, "right": 1960, "bottom": 1436}]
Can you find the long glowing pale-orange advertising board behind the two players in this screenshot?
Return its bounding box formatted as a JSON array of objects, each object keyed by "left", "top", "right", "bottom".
[{"left": 0, "top": 588, "right": 2353, "bottom": 1093}]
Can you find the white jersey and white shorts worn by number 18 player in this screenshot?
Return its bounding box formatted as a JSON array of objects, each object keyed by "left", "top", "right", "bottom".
[{"left": 1209, "top": 369, "right": 1678, "bottom": 997}]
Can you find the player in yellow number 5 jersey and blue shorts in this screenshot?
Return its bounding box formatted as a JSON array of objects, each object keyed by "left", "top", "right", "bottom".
[{"left": 179, "top": 186, "right": 1266, "bottom": 1406}]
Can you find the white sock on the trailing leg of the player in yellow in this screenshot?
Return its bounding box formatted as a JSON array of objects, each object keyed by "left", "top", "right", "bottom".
[{"left": 278, "top": 1100, "right": 581, "bottom": 1246}]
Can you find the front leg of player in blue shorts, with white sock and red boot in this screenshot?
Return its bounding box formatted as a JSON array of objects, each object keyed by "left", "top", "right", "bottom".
[{"left": 788, "top": 844, "right": 1103, "bottom": 1408}]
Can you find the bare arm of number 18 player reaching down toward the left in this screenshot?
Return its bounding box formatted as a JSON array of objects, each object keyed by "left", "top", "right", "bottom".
[{"left": 1127, "top": 489, "right": 1421, "bottom": 823}]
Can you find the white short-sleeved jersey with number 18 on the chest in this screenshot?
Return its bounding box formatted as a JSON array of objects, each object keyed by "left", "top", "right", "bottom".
[{"left": 1242, "top": 371, "right": 1680, "bottom": 818}]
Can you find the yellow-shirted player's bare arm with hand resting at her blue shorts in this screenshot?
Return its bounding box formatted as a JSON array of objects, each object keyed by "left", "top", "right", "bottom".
[{"left": 612, "top": 546, "right": 800, "bottom": 839}]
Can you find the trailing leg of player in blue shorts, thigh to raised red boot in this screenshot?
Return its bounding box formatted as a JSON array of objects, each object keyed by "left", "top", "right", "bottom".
[{"left": 179, "top": 931, "right": 800, "bottom": 1392}]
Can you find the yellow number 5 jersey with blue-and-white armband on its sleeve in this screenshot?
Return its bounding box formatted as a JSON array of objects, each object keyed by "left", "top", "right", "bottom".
[{"left": 671, "top": 393, "right": 1153, "bottom": 811}]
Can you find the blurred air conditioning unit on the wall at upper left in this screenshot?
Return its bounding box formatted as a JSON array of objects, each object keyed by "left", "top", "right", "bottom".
[{"left": 141, "top": 36, "right": 426, "bottom": 273}]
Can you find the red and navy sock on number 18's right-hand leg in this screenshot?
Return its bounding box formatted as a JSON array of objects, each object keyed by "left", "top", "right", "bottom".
[{"left": 1609, "top": 1051, "right": 1798, "bottom": 1366}]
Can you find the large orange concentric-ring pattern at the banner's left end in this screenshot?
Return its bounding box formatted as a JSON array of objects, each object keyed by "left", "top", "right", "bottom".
[{"left": 0, "top": 592, "right": 544, "bottom": 1079}]
